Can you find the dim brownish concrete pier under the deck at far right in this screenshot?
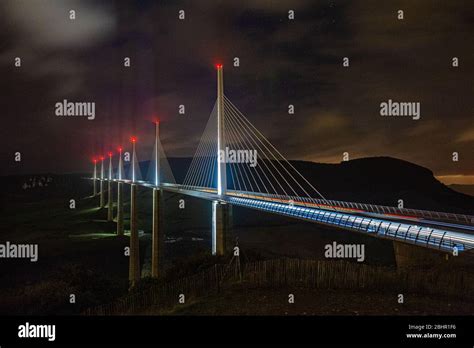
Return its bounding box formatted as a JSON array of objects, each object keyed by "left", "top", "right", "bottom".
[{"left": 393, "top": 241, "right": 451, "bottom": 269}]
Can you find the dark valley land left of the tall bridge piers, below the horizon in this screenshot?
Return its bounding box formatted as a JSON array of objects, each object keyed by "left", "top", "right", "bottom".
[{"left": 0, "top": 178, "right": 128, "bottom": 314}]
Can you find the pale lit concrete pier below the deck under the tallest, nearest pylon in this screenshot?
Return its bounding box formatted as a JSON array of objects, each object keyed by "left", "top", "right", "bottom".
[{"left": 212, "top": 201, "right": 232, "bottom": 256}]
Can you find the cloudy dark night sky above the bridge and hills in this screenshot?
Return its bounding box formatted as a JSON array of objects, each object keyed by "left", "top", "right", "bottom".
[{"left": 0, "top": 0, "right": 474, "bottom": 184}]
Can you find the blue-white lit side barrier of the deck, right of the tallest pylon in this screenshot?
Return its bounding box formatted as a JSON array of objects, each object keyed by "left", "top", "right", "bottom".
[{"left": 228, "top": 197, "right": 474, "bottom": 252}]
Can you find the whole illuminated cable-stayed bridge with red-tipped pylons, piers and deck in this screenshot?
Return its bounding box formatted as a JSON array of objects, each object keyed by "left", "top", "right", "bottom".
[{"left": 92, "top": 65, "right": 474, "bottom": 282}]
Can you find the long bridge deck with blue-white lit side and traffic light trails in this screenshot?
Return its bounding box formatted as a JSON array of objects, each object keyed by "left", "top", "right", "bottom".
[{"left": 93, "top": 180, "right": 474, "bottom": 252}]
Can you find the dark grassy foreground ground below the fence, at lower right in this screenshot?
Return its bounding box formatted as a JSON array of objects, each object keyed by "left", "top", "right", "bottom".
[{"left": 142, "top": 285, "right": 474, "bottom": 316}]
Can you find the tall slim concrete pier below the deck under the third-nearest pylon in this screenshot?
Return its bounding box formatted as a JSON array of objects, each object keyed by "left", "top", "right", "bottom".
[{"left": 128, "top": 184, "right": 140, "bottom": 286}]
